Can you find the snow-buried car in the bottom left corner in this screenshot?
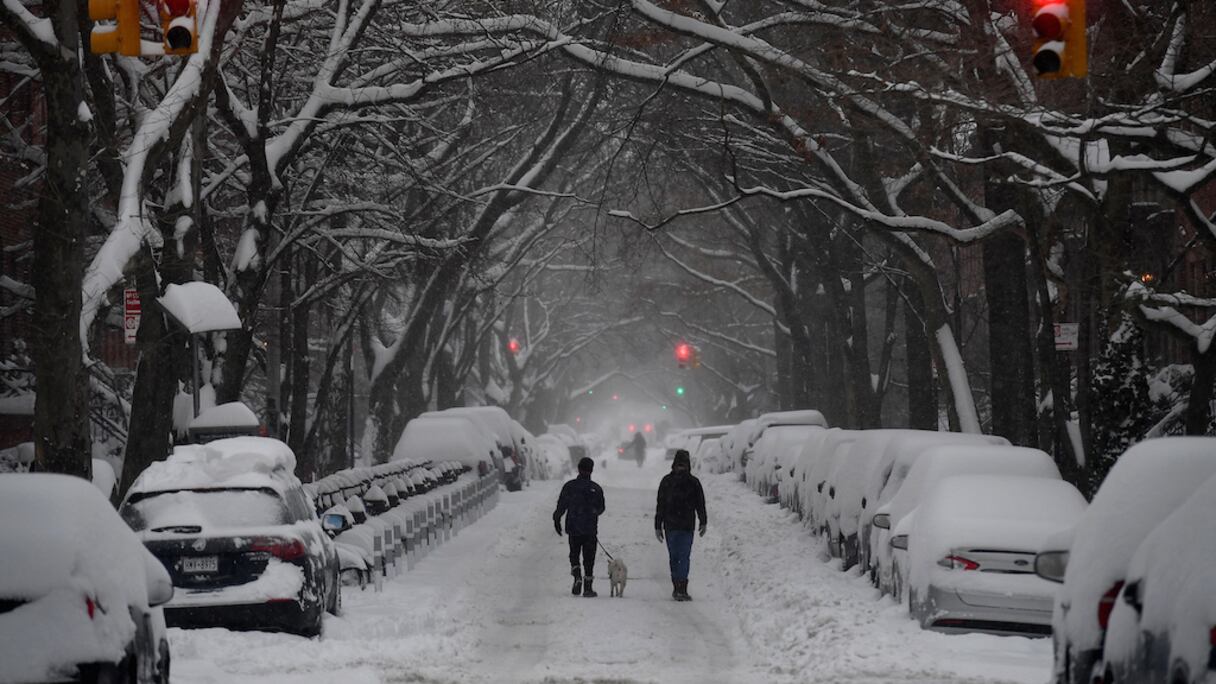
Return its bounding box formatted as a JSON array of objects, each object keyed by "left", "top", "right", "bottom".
[{"left": 0, "top": 473, "right": 173, "bottom": 683}]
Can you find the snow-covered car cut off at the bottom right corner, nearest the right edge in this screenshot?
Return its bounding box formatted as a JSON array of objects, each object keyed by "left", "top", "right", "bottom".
[{"left": 1103, "top": 467, "right": 1216, "bottom": 684}]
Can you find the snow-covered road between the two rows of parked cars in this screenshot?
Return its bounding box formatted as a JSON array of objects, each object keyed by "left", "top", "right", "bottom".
[{"left": 170, "top": 453, "right": 1051, "bottom": 684}]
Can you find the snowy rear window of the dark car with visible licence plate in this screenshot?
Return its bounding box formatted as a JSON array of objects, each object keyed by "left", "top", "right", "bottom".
[{"left": 120, "top": 489, "right": 291, "bottom": 532}]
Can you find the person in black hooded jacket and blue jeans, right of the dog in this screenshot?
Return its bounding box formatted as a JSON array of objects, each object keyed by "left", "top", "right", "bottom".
[{"left": 654, "top": 449, "right": 706, "bottom": 601}]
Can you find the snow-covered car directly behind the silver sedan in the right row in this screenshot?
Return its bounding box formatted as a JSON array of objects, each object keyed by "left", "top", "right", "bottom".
[{"left": 874, "top": 444, "right": 1060, "bottom": 601}]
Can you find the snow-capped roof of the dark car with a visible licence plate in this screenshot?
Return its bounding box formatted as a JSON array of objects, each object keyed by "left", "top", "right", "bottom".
[{"left": 130, "top": 437, "right": 299, "bottom": 493}]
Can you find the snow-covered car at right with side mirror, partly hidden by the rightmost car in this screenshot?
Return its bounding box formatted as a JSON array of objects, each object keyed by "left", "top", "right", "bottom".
[{"left": 1052, "top": 437, "right": 1216, "bottom": 684}]
